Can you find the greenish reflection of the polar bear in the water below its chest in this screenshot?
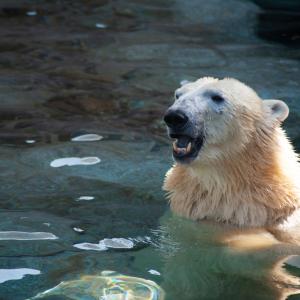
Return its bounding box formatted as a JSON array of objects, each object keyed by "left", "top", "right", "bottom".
[{"left": 158, "top": 216, "right": 300, "bottom": 300}]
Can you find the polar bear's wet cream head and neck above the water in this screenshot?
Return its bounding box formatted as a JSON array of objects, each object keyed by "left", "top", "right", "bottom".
[{"left": 163, "top": 77, "right": 300, "bottom": 228}]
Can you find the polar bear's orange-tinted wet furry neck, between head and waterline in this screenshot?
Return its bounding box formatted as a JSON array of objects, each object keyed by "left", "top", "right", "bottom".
[{"left": 164, "top": 128, "right": 300, "bottom": 226}]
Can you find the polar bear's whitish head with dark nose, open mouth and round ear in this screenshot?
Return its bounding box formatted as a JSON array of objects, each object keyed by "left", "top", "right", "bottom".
[{"left": 164, "top": 77, "right": 289, "bottom": 163}]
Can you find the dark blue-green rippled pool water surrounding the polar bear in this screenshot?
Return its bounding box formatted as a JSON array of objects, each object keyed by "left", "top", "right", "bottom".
[{"left": 0, "top": 0, "right": 300, "bottom": 300}]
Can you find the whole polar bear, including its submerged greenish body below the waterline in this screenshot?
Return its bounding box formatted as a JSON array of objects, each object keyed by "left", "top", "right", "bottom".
[{"left": 162, "top": 77, "right": 300, "bottom": 300}]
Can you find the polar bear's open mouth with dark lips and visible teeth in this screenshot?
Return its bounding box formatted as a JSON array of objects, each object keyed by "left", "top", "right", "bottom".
[{"left": 170, "top": 134, "right": 204, "bottom": 163}]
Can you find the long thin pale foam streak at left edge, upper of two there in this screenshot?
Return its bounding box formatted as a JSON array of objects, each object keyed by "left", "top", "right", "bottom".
[{"left": 0, "top": 231, "right": 58, "bottom": 241}]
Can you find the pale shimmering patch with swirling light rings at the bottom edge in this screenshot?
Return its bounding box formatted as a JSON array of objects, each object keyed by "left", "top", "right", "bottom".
[{"left": 30, "top": 271, "right": 164, "bottom": 300}]
